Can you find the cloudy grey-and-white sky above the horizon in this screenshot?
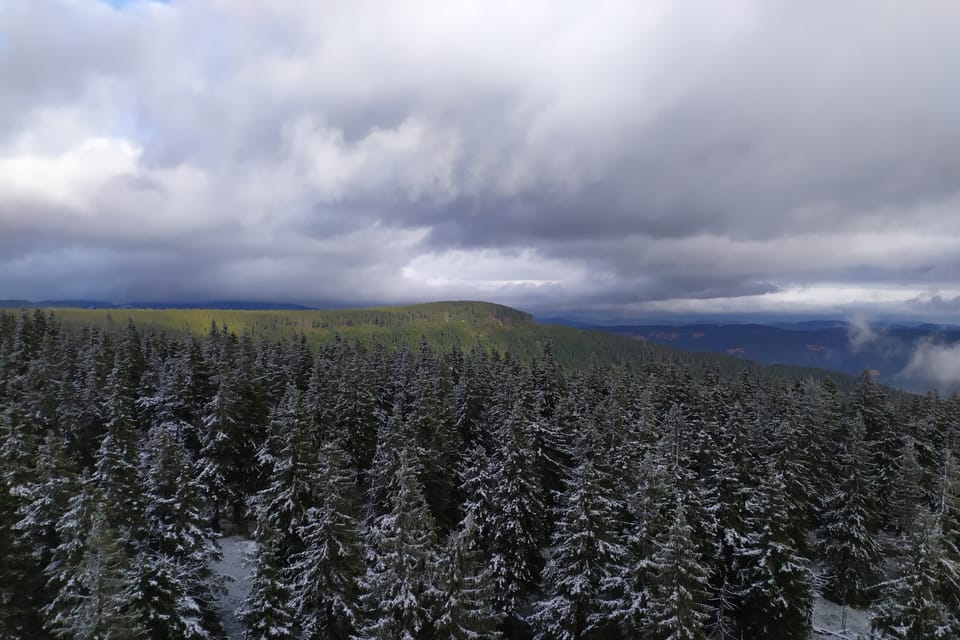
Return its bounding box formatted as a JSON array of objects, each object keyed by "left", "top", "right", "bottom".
[{"left": 0, "top": 0, "right": 960, "bottom": 321}]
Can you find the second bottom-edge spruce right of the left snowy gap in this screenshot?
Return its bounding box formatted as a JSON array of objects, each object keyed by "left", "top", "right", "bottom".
[{"left": 289, "top": 440, "right": 363, "bottom": 640}]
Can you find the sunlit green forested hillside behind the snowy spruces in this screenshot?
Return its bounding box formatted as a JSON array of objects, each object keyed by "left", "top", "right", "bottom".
[{"left": 13, "top": 301, "right": 872, "bottom": 390}]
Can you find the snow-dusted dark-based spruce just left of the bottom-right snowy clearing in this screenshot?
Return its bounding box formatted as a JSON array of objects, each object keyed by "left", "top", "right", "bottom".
[{"left": 736, "top": 464, "right": 813, "bottom": 640}]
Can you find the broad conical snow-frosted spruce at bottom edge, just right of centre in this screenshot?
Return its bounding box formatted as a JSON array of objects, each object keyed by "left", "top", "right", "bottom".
[{"left": 531, "top": 425, "right": 627, "bottom": 640}]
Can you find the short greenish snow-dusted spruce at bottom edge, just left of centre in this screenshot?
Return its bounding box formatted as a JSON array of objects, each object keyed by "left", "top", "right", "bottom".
[{"left": 435, "top": 508, "right": 501, "bottom": 640}]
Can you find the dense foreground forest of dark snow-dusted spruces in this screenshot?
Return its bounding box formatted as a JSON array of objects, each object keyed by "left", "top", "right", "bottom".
[{"left": 0, "top": 310, "right": 960, "bottom": 640}]
